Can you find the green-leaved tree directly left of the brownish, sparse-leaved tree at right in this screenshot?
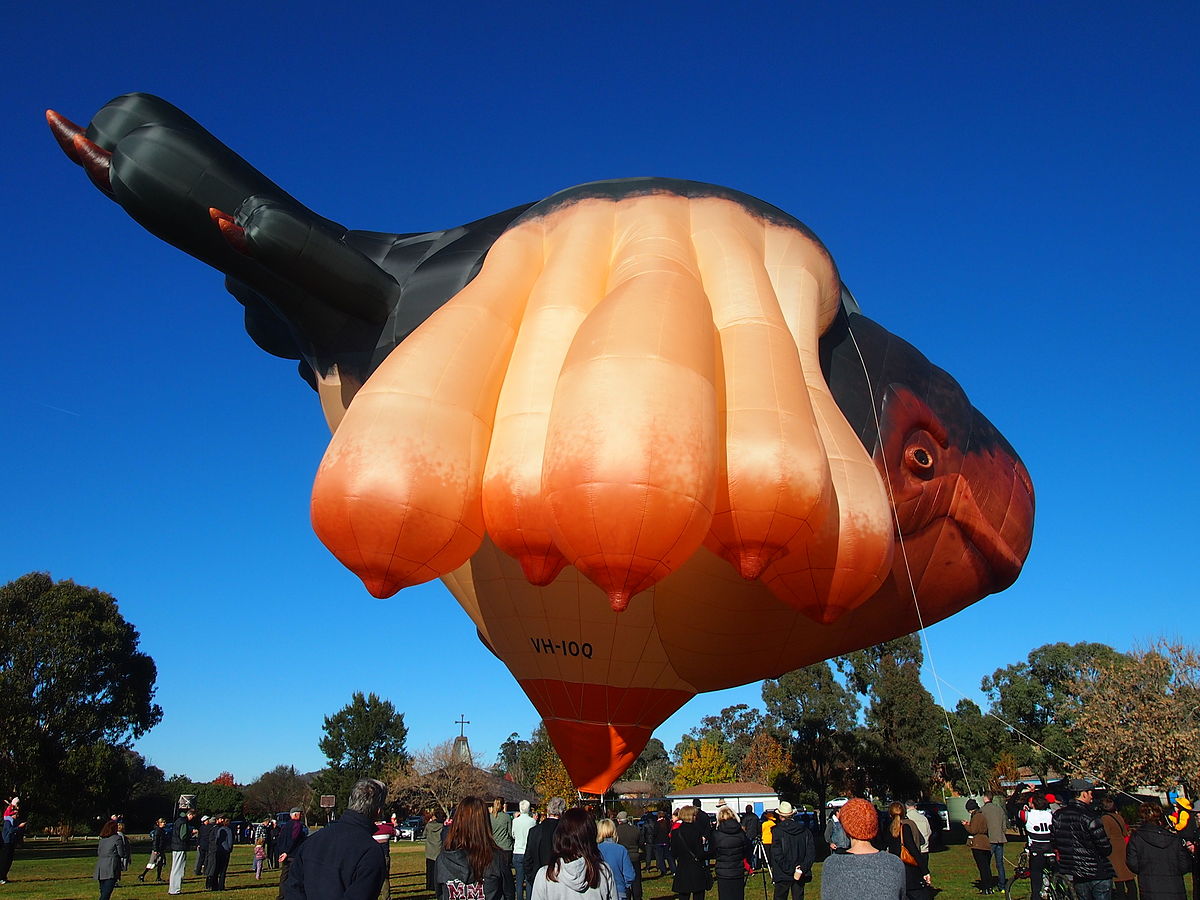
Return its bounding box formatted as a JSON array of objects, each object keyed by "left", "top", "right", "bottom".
[{"left": 980, "top": 642, "right": 1123, "bottom": 778}]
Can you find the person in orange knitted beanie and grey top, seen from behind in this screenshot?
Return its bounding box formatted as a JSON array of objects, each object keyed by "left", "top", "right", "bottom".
[{"left": 821, "top": 797, "right": 905, "bottom": 900}]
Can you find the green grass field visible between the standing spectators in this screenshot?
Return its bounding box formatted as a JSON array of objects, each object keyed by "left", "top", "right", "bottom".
[{"left": 0, "top": 839, "right": 1185, "bottom": 900}]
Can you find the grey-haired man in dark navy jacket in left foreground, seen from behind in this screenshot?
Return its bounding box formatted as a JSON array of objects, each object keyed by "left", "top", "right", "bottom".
[{"left": 283, "top": 778, "right": 388, "bottom": 900}]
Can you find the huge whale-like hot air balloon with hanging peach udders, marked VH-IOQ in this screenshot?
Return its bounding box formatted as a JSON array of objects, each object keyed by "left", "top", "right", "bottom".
[{"left": 47, "top": 94, "right": 1033, "bottom": 792}]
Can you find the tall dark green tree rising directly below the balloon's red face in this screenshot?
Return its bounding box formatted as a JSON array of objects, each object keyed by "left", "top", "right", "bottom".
[{"left": 839, "top": 635, "right": 946, "bottom": 797}]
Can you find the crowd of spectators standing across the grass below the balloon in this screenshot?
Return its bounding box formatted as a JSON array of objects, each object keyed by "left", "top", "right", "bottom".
[{"left": 7, "top": 779, "right": 1200, "bottom": 900}]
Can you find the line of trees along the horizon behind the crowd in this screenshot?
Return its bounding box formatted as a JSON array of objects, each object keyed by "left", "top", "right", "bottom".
[{"left": 0, "top": 572, "right": 1200, "bottom": 834}]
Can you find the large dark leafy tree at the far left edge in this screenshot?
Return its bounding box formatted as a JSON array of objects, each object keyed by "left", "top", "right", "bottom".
[{"left": 0, "top": 572, "right": 162, "bottom": 822}]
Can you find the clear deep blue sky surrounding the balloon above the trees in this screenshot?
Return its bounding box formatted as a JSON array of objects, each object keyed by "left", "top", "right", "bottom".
[{"left": 0, "top": 1, "right": 1200, "bottom": 781}]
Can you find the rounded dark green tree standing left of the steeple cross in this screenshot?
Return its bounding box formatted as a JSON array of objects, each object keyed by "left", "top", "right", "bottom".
[{"left": 312, "top": 691, "right": 408, "bottom": 810}]
